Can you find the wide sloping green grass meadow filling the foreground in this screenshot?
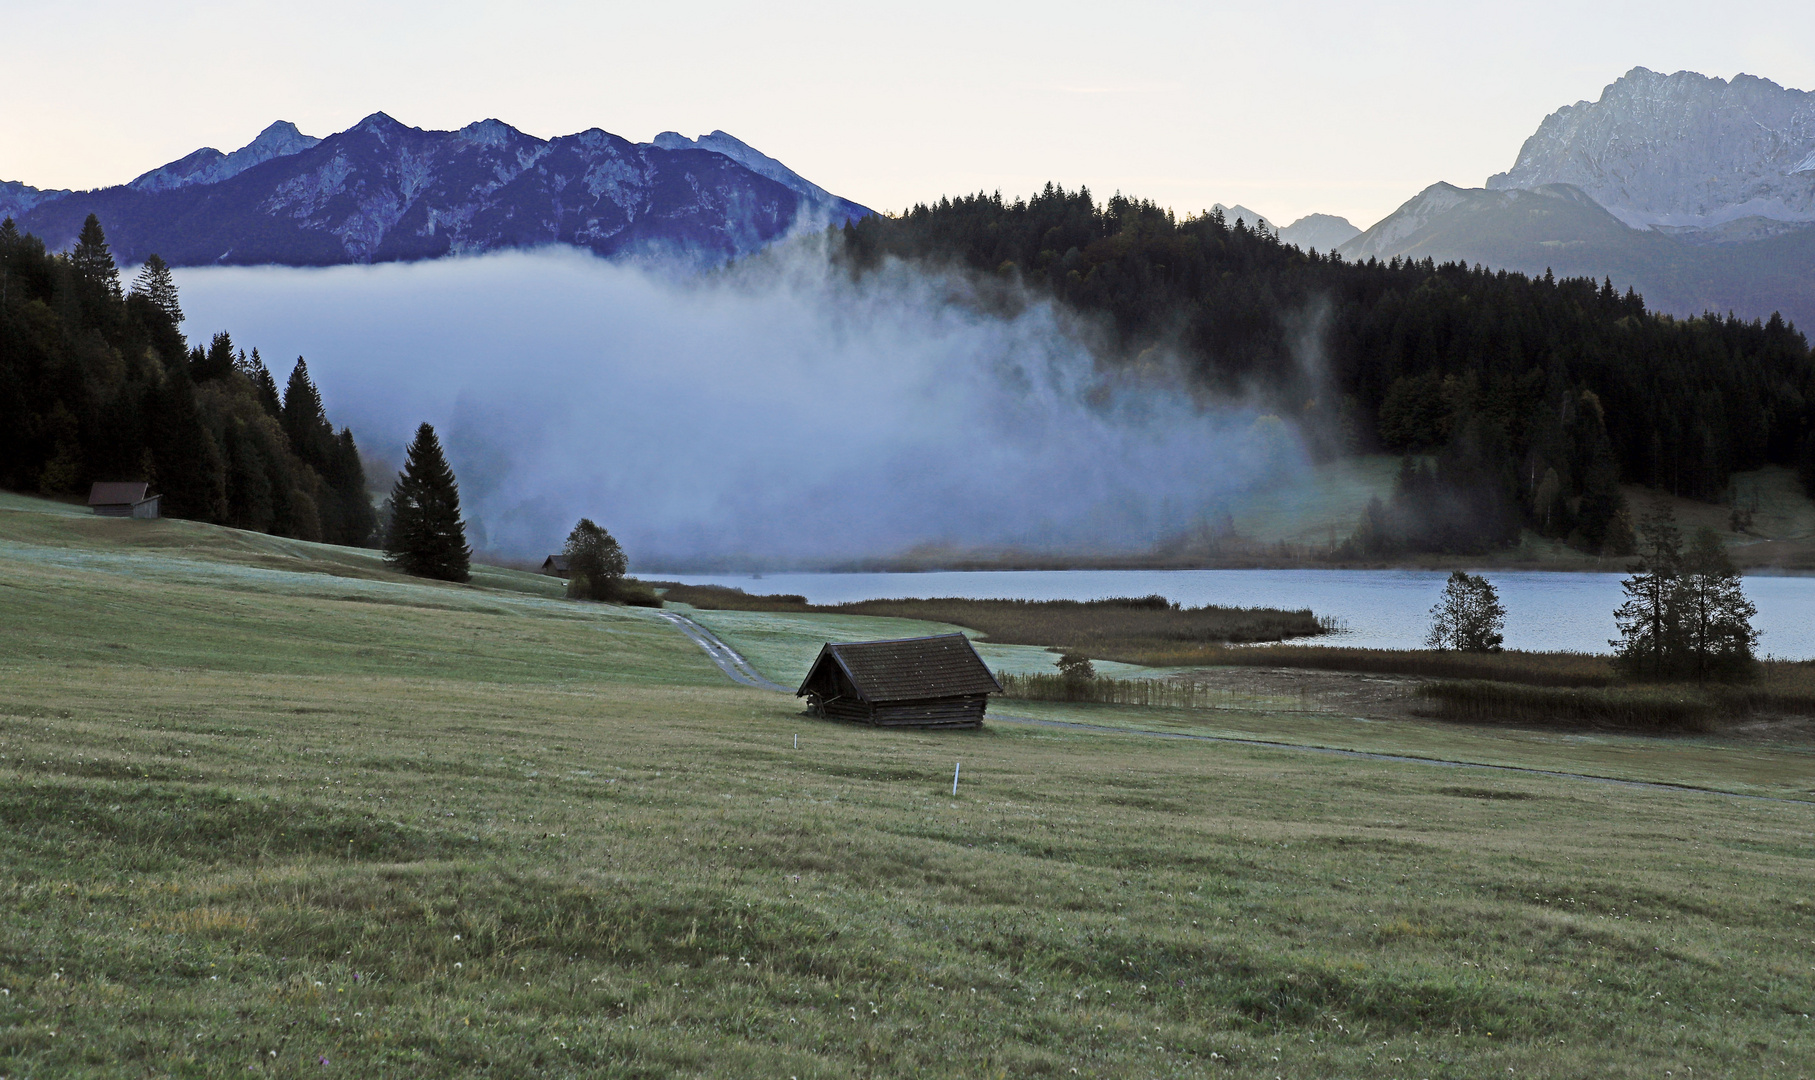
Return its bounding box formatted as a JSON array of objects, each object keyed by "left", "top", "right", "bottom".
[{"left": 0, "top": 499, "right": 1815, "bottom": 1078}]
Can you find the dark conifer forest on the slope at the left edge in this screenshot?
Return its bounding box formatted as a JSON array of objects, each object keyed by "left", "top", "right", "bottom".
[{"left": 0, "top": 214, "right": 378, "bottom": 545}]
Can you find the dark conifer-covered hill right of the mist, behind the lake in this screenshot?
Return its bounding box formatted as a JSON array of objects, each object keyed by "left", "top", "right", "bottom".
[{"left": 839, "top": 183, "right": 1815, "bottom": 554}]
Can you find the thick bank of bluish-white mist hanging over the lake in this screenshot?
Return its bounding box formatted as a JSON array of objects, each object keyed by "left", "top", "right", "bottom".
[{"left": 178, "top": 247, "right": 1305, "bottom": 568}]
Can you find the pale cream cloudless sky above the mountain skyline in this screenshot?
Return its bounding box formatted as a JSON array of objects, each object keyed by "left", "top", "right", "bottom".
[{"left": 0, "top": 0, "right": 1815, "bottom": 227}]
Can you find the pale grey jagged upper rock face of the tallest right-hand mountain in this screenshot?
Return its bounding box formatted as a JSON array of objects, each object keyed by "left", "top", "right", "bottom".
[{"left": 1486, "top": 67, "right": 1815, "bottom": 229}]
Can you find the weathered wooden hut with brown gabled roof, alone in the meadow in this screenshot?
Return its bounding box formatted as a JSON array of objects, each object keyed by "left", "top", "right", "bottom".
[{"left": 795, "top": 633, "right": 1002, "bottom": 728}]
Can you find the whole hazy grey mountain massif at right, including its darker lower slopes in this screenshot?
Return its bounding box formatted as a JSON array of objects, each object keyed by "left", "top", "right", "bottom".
[{"left": 1336, "top": 67, "right": 1815, "bottom": 327}]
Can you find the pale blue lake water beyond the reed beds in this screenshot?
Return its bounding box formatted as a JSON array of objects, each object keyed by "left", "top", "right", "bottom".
[{"left": 652, "top": 570, "right": 1815, "bottom": 659}]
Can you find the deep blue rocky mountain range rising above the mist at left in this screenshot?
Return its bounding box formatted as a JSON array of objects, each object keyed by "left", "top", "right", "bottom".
[{"left": 0, "top": 113, "right": 869, "bottom": 267}]
